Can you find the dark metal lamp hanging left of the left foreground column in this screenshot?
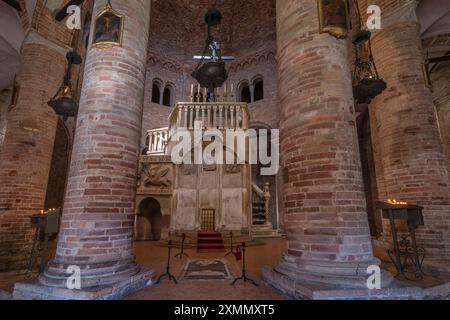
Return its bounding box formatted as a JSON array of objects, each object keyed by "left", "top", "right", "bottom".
[{"left": 47, "top": 51, "right": 82, "bottom": 121}]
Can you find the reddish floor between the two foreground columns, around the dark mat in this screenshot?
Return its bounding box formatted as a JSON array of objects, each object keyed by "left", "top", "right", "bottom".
[{"left": 128, "top": 239, "right": 287, "bottom": 300}]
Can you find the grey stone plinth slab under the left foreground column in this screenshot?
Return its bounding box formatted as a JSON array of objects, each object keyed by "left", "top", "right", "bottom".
[{"left": 13, "top": 270, "right": 155, "bottom": 300}]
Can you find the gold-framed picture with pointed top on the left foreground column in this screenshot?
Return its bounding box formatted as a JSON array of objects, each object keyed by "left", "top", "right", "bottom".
[{"left": 92, "top": 1, "right": 125, "bottom": 47}]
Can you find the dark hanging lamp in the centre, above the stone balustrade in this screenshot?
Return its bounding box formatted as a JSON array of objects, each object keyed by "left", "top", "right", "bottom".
[{"left": 191, "top": 9, "right": 228, "bottom": 100}]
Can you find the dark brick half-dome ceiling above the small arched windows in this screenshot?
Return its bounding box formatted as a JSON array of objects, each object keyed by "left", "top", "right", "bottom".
[{"left": 149, "top": 0, "right": 276, "bottom": 63}]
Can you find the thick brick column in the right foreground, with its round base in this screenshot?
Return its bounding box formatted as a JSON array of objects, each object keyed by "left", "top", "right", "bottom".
[{"left": 264, "top": 0, "right": 379, "bottom": 296}]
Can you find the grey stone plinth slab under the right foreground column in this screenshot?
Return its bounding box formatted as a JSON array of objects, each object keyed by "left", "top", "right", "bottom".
[{"left": 262, "top": 267, "right": 424, "bottom": 300}]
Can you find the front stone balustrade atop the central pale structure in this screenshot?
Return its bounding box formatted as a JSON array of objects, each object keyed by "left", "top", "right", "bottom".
[{"left": 169, "top": 102, "right": 250, "bottom": 132}]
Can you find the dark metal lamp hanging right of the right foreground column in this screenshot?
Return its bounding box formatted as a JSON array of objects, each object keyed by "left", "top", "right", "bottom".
[{"left": 352, "top": 0, "right": 387, "bottom": 104}]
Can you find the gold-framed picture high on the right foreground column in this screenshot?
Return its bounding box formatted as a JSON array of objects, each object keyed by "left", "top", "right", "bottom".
[{"left": 317, "top": 0, "right": 349, "bottom": 39}]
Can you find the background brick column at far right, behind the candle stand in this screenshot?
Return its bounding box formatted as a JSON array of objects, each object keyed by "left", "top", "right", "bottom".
[{"left": 370, "top": 1, "right": 450, "bottom": 262}]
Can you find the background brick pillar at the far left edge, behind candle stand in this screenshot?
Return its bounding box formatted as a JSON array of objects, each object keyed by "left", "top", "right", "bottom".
[{"left": 0, "top": 41, "right": 67, "bottom": 271}]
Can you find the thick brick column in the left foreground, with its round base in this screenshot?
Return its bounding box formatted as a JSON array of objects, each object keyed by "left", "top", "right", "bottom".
[{"left": 40, "top": 0, "right": 151, "bottom": 288}]
